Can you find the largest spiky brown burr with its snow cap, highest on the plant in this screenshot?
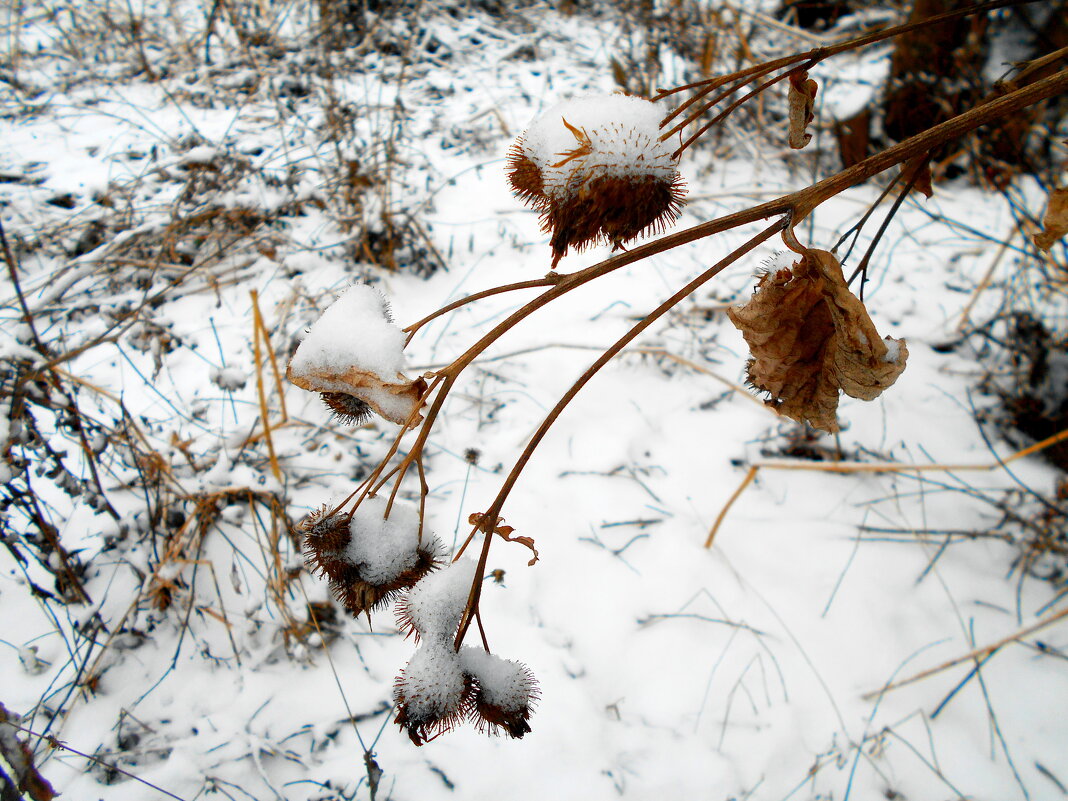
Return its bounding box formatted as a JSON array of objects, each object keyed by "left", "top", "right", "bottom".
[{"left": 507, "top": 94, "right": 685, "bottom": 267}]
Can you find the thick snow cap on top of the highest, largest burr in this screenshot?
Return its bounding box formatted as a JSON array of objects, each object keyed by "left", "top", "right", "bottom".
[{"left": 522, "top": 95, "right": 676, "bottom": 198}]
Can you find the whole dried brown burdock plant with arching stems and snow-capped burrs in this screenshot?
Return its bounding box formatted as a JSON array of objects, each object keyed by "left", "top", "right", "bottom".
[{"left": 289, "top": 0, "right": 1068, "bottom": 744}]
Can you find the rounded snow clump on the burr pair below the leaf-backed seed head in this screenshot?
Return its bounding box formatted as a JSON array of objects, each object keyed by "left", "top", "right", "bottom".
[{"left": 343, "top": 496, "right": 419, "bottom": 584}]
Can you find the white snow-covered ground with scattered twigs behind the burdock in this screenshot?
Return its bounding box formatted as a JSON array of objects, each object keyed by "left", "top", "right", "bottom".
[{"left": 0, "top": 2, "right": 1068, "bottom": 801}]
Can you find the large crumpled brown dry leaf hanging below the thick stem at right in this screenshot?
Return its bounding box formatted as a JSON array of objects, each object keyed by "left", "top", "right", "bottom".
[{"left": 727, "top": 250, "right": 909, "bottom": 431}]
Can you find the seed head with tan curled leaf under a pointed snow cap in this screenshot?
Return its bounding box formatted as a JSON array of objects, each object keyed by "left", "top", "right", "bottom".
[{"left": 285, "top": 284, "right": 426, "bottom": 424}]
